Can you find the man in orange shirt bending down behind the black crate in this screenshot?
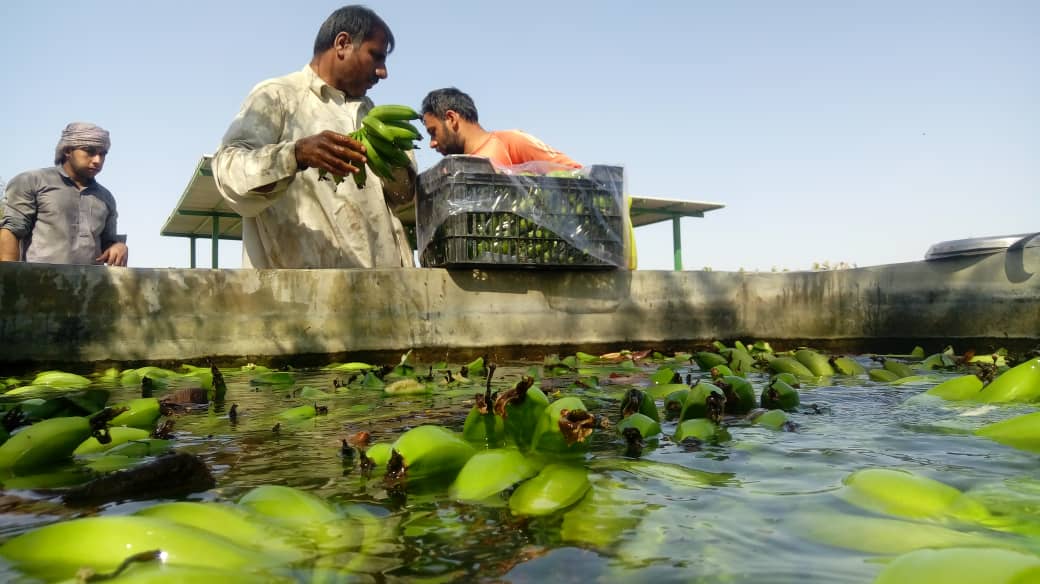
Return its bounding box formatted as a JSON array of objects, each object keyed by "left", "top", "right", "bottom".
[{"left": 422, "top": 87, "right": 581, "bottom": 168}]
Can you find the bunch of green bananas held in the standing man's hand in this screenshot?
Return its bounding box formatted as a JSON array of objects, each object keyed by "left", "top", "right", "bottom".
[{"left": 318, "top": 105, "right": 422, "bottom": 188}]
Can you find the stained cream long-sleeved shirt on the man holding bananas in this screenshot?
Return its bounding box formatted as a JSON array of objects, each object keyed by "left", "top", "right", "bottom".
[{"left": 212, "top": 64, "right": 414, "bottom": 268}]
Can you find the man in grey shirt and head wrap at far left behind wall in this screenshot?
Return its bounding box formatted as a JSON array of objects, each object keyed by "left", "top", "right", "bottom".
[{"left": 0, "top": 123, "right": 127, "bottom": 266}]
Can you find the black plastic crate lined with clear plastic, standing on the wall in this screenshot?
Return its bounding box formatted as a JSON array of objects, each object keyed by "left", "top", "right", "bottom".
[{"left": 417, "top": 156, "right": 624, "bottom": 268}]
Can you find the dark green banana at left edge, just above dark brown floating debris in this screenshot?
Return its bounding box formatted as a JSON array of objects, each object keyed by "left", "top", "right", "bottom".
[{"left": 0, "top": 417, "right": 90, "bottom": 472}]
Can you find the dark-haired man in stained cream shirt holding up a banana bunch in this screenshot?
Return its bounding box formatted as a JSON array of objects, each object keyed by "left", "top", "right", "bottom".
[{"left": 213, "top": 5, "right": 415, "bottom": 268}]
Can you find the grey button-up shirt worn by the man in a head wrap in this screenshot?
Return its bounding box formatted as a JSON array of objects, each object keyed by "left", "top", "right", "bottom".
[{"left": 0, "top": 166, "right": 123, "bottom": 264}]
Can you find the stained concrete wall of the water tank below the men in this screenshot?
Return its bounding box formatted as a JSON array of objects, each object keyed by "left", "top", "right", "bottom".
[{"left": 0, "top": 248, "right": 1040, "bottom": 366}]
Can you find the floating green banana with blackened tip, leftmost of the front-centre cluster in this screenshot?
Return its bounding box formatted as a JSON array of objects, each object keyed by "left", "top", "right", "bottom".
[{"left": 387, "top": 425, "right": 476, "bottom": 482}]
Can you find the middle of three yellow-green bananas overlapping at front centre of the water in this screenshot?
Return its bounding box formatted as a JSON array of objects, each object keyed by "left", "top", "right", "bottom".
[{"left": 449, "top": 449, "right": 539, "bottom": 501}]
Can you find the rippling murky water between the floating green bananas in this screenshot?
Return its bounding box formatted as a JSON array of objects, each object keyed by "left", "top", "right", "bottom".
[{"left": 0, "top": 353, "right": 1040, "bottom": 584}]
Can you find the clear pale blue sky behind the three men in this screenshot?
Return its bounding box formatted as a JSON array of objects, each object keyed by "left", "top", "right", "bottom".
[{"left": 0, "top": 0, "right": 1040, "bottom": 270}]
